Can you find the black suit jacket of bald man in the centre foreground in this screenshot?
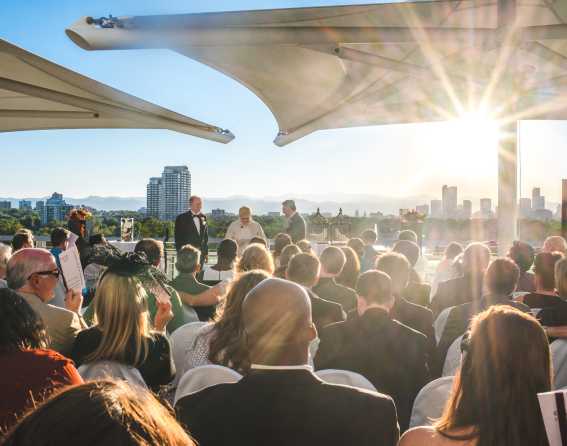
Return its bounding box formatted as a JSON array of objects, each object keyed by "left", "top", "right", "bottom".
[{"left": 175, "top": 370, "right": 399, "bottom": 446}]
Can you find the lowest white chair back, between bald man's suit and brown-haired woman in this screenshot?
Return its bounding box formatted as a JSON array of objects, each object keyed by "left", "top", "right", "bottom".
[{"left": 410, "top": 376, "right": 455, "bottom": 428}]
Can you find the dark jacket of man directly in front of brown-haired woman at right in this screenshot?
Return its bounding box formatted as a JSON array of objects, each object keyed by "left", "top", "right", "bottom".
[{"left": 437, "top": 296, "right": 530, "bottom": 363}]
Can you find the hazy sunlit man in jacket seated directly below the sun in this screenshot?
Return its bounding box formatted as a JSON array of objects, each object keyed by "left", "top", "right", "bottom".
[{"left": 431, "top": 243, "right": 490, "bottom": 317}]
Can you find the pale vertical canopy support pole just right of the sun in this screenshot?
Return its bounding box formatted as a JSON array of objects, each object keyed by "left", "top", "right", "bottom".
[{"left": 498, "top": 121, "right": 519, "bottom": 255}]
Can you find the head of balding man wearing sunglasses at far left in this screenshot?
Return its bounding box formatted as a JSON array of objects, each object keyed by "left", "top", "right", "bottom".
[{"left": 6, "top": 248, "right": 57, "bottom": 290}]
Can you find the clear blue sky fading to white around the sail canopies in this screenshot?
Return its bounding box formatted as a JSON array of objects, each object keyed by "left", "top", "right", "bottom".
[{"left": 0, "top": 0, "right": 567, "bottom": 206}]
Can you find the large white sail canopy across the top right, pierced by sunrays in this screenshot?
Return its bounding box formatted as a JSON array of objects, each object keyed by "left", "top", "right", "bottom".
[{"left": 67, "top": 0, "right": 567, "bottom": 145}]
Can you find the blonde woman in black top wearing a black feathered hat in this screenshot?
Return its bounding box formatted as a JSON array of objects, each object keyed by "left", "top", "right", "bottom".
[{"left": 71, "top": 254, "right": 175, "bottom": 389}]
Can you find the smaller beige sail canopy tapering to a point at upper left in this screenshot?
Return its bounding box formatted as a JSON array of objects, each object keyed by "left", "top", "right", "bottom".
[{"left": 0, "top": 39, "right": 234, "bottom": 143}]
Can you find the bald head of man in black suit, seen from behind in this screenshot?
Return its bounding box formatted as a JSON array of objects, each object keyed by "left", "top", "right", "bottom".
[{"left": 242, "top": 279, "right": 317, "bottom": 364}]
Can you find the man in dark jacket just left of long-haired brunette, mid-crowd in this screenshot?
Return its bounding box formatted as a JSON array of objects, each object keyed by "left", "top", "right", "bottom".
[{"left": 313, "top": 246, "right": 357, "bottom": 313}]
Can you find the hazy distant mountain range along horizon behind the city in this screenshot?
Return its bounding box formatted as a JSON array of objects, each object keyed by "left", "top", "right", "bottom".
[{"left": 0, "top": 194, "right": 557, "bottom": 215}]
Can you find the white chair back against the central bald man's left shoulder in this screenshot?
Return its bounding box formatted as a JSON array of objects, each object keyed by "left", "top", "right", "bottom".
[{"left": 173, "top": 364, "right": 242, "bottom": 405}]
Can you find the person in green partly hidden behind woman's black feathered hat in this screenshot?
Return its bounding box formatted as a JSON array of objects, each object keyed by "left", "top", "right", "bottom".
[{"left": 134, "top": 238, "right": 199, "bottom": 333}]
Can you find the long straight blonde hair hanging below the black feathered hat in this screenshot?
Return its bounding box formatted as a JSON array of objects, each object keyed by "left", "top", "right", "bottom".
[{"left": 86, "top": 273, "right": 151, "bottom": 367}]
